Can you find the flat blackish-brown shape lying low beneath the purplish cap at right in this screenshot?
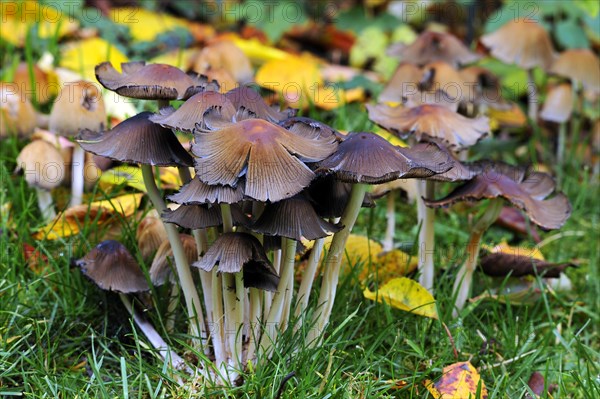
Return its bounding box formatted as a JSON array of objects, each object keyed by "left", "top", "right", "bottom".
[{"left": 481, "top": 252, "right": 575, "bottom": 278}]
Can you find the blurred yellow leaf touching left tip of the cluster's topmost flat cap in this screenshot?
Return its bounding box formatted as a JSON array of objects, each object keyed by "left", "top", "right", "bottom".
[{"left": 60, "top": 37, "right": 128, "bottom": 82}]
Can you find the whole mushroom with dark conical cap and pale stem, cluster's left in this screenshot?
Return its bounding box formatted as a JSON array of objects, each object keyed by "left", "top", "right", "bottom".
[{"left": 78, "top": 112, "right": 204, "bottom": 348}]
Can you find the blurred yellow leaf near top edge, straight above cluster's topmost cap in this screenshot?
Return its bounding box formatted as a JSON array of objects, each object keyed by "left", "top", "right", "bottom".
[{"left": 110, "top": 7, "right": 188, "bottom": 42}]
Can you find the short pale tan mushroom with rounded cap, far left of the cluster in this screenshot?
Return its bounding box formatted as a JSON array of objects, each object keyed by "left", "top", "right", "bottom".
[{"left": 15, "top": 140, "right": 65, "bottom": 221}]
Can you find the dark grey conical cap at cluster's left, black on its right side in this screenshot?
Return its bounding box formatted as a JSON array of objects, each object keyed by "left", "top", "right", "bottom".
[{"left": 77, "top": 112, "right": 193, "bottom": 166}]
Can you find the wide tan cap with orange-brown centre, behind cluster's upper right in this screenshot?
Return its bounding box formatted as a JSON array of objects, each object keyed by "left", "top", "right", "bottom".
[{"left": 367, "top": 104, "right": 490, "bottom": 150}]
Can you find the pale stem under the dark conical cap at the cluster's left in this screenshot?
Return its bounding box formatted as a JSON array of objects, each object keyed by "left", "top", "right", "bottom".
[{"left": 141, "top": 164, "right": 206, "bottom": 346}]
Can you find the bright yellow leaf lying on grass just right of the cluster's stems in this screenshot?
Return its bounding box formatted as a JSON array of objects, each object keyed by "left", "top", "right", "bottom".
[{"left": 363, "top": 277, "right": 438, "bottom": 319}]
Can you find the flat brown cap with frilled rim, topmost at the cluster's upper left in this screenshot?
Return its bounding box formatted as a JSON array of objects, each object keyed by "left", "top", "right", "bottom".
[{"left": 96, "top": 61, "right": 219, "bottom": 100}]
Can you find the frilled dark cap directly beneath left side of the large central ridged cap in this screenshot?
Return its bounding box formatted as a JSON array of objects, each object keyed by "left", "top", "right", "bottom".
[{"left": 168, "top": 177, "right": 244, "bottom": 205}]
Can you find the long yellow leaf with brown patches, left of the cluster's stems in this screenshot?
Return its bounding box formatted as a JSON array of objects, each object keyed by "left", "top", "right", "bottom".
[{"left": 33, "top": 194, "right": 143, "bottom": 240}]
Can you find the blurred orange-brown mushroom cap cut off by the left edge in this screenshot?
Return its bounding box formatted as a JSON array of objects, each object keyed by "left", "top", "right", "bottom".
[{"left": 0, "top": 82, "right": 36, "bottom": 139}]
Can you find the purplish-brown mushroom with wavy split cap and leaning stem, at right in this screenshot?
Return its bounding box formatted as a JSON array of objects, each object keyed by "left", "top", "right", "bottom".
[{"left": 425, "top": 162, "right": 571, "bottom": 316}]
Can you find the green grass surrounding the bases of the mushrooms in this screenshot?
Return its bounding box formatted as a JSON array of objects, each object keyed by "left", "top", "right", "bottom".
[{"left": 0, "top": 110, "right": 600, "bottom": 398}]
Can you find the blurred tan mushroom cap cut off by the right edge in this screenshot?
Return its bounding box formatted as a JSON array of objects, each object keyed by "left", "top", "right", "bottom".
[{"left": 550, "top": 48, "right": 600, "bottom": 93}]
